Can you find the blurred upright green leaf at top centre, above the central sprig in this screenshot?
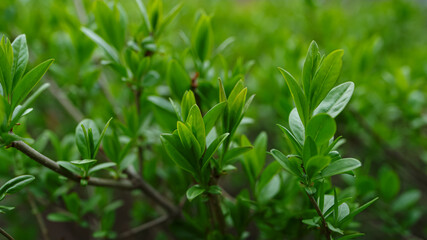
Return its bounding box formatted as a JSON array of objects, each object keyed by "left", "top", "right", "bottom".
[{"left": 191, "top": 13, "right": 214, "bottom": 62}]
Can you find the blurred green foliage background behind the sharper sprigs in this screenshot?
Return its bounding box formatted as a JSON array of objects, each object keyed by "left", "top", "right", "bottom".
[{"left": 0, "top": 0, "right": 427, "bottom": 239}]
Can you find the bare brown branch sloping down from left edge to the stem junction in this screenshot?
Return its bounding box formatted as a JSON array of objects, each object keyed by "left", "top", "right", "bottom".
[{"left": 11, "top": 141, "right": 136, "bottom": 189}]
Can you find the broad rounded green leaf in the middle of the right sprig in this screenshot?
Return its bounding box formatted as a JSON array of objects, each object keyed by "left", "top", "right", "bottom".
[{"left": 306, "top": 113, "right": 337, "bottom": 146}]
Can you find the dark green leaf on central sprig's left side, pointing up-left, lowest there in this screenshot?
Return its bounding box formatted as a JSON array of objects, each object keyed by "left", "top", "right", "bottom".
[{"left": 160, "top": 134, "right": 195, "bottom": 174}]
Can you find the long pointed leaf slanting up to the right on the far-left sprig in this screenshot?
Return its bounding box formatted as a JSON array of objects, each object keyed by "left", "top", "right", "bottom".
[{"left": 12, "top": 59, "right": 53, "bottom": 107}]
